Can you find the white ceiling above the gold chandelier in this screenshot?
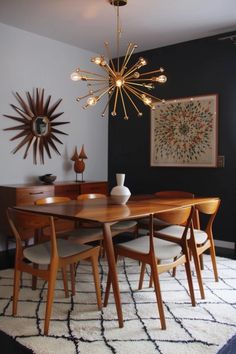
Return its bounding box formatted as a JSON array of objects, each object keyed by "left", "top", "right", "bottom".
[{"left": 0, "top": 0, "right": 236, "bottom": 56}]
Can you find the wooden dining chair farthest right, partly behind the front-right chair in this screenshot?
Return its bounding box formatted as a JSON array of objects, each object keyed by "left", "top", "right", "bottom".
[{"left": 155, "top": 198, "right": 220, "bottom": 299}]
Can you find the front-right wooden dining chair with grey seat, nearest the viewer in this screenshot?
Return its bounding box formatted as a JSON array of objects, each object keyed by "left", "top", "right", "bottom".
[{"left": 104, "top": 207, "right": 196, "bottom": 329}]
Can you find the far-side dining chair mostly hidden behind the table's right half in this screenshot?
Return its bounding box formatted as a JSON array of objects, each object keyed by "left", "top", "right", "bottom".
[{"left": 138, "top": 190, "right": 194, "bottom": 230}]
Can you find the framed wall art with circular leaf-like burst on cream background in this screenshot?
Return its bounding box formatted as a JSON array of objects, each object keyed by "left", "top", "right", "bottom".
[{"left": 150, "top": 94, "right": 218, "bottom": 167}]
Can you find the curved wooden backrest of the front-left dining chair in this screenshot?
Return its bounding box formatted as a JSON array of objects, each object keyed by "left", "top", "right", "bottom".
[{"left": 7, "top": 207, "right": 56, "bottom": 251}]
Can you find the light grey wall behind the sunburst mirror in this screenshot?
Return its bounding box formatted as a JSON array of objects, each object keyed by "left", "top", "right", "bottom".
[{"left": 0, "top": 23, "right": 108, "bottom": 185}]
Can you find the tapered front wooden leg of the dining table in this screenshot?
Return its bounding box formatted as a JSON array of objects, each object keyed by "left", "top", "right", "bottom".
[{"left": 103, "top": 223, "right": 124, "bottom": 328}]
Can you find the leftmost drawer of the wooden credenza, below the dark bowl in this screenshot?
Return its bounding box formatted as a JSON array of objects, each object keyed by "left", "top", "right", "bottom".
[{"left": 16, "top": 185, "right": 54, "bottom": 205}]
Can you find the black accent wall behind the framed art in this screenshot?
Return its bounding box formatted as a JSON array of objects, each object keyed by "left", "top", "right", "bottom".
[{"left": 108, "top": 33, "right": 236, "bottom": 242}]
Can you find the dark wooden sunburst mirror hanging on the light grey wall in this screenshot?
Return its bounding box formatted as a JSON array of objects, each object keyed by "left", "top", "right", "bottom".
[{"left": 4, "top": 88, "right": 69, "bottom": 164}]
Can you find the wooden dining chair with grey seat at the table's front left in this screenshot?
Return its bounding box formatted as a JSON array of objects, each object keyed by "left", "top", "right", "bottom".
[{"left": 7, "top": 208, "right": 102, "bottom": 335}]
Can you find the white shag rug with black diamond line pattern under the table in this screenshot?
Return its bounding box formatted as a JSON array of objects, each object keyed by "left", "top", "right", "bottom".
[{"left": 0, "top": 255, "right": 236, "bottom": 354}]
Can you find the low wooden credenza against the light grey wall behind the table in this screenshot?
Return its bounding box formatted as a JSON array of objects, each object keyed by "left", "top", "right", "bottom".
[{"left": 0, "top": 181, "right": 108, "bottom": 242}]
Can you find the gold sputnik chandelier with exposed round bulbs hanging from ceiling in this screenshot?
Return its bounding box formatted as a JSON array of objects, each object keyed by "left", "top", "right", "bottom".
[{"left": 71, "top": 0, "right": 167, "bottom": 119}]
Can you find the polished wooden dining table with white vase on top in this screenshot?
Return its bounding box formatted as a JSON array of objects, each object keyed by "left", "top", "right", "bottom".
[{"left": 15, "top": 195, "right": 219, "bottom": 327}]
